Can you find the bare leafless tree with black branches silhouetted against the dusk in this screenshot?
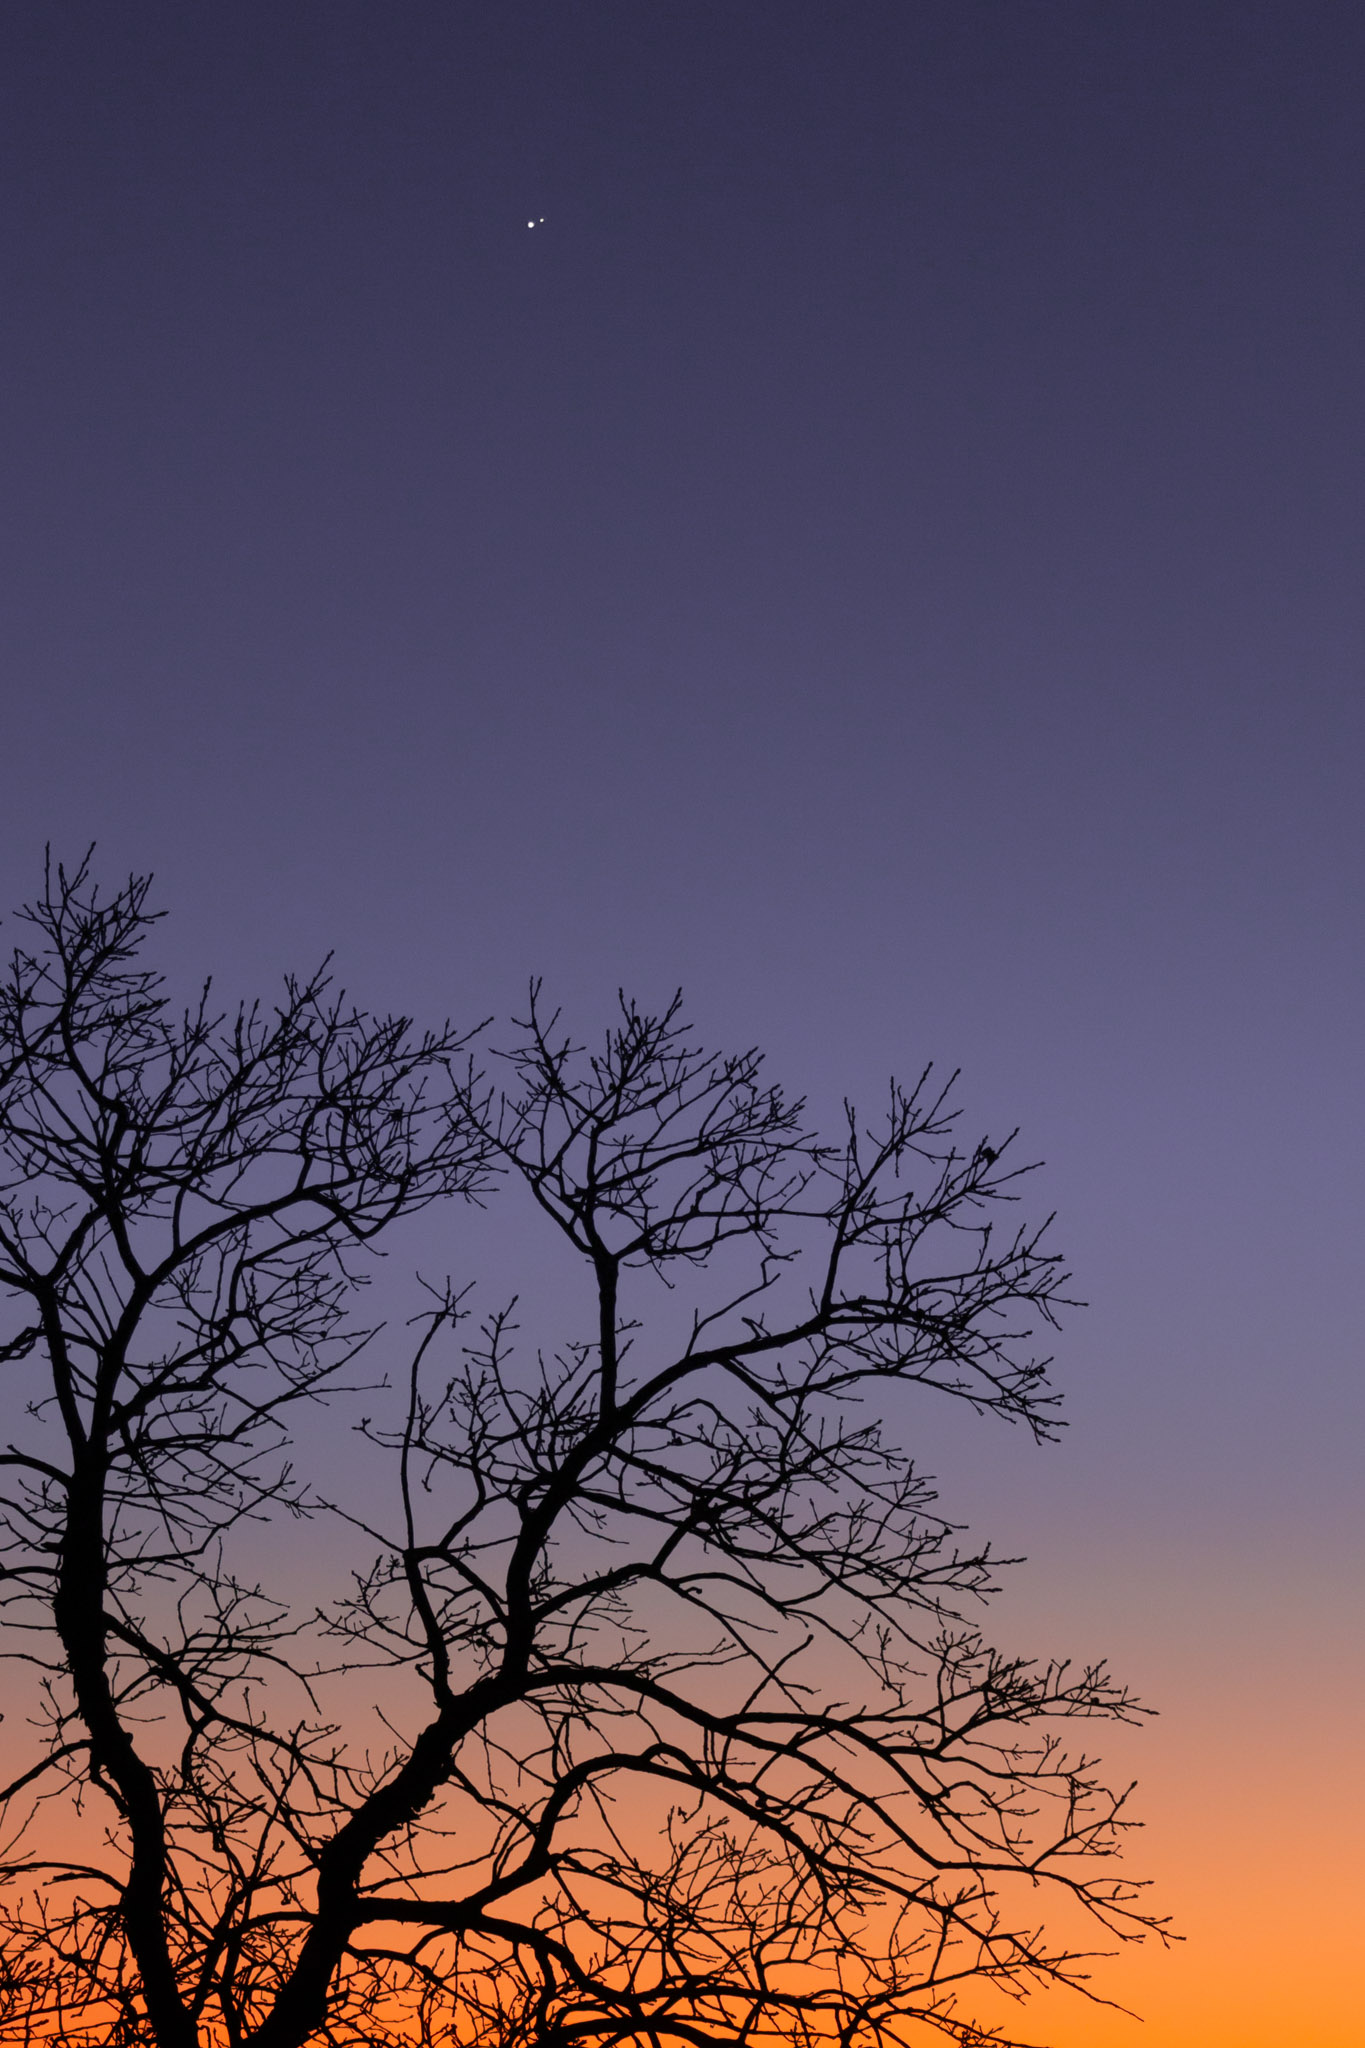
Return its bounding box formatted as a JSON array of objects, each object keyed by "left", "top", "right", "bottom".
[{"left": 0, "top": 866, "right": 1156, "bottom": 2048}]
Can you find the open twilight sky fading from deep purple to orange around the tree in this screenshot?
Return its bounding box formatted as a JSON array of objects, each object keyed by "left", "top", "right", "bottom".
[{"left": 0, "top": 0, "right": 1365, "bottom": 2048}]
